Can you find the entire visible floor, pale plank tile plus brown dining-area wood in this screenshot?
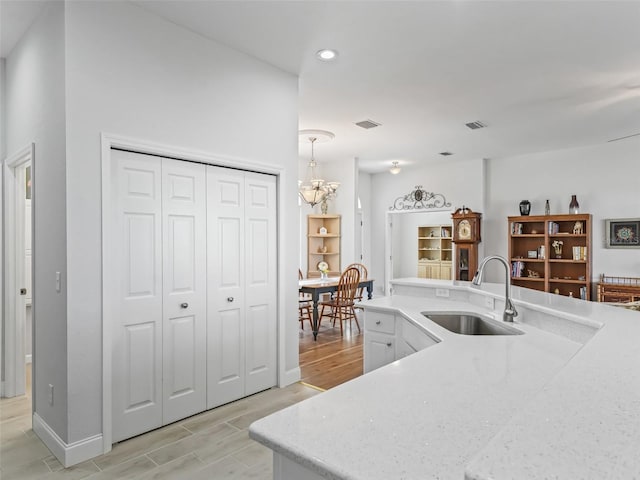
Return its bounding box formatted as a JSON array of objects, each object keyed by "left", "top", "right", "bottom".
[{"left": 0, "top": 321, "right": 363, "bottom": 480}]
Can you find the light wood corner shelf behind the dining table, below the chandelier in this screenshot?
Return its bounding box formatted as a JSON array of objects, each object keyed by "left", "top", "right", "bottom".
[{"left": 307, "top": 215, "right": 342, "bottom": 278}]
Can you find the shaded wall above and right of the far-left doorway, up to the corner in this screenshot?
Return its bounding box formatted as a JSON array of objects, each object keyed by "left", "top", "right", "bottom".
[{"left": 6, "top": 1, "right": 67, "bottom": 439}]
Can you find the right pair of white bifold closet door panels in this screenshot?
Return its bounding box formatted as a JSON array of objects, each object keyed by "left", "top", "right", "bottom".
[{"left": 207, "top": 167, "right": 277, "bottom": 408}]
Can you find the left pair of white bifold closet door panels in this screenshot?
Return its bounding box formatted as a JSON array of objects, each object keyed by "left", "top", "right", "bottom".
[{"left": 111, "top": 150, "right": 206, "bottom": 441}]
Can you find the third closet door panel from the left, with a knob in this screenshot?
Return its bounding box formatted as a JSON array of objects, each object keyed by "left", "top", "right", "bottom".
[{"left": 207, "top": 166, "right": 245, "bottom": 408}]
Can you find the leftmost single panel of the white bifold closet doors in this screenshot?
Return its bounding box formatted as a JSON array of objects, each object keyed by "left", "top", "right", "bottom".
[{"left": 109, "top": 150, "right": 162, "bottom": 442}]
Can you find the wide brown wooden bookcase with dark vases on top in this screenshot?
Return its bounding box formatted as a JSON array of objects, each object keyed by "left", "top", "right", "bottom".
[{"left": 508, "top": 214, "right": 593, "bottom": 300}]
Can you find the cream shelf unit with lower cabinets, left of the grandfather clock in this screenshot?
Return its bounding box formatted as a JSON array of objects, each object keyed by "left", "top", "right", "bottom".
[{"left": 418, "top": 225, "right": 453, "bottom": 280}]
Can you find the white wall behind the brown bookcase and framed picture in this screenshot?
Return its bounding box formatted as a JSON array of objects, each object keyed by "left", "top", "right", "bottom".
[{"left": 483, "top": 137, "right": 640, "bottom": 281}]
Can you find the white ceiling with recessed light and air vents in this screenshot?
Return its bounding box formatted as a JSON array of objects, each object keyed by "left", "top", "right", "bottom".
[{"left": 2, "top": 0, "right": 640, "bottom": 172}]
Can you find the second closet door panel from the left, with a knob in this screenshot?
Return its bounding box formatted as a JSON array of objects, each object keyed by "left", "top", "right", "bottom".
[{"left": 162, "top": 158, "right": 207, "bottom": 424}]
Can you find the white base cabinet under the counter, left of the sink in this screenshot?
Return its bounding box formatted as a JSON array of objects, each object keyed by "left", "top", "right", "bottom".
[{"left": 364, "top": 310, "right": 438, "bottom": 373}]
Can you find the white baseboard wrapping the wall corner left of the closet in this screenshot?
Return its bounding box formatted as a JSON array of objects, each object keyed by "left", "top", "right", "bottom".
[{"left": 33, "top": 413, "right": 103, "bottom": 468}]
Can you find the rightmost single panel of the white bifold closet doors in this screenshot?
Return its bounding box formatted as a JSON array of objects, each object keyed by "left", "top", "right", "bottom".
[{"left": 245, "top": 172, "right": 278, "bottom": 395}]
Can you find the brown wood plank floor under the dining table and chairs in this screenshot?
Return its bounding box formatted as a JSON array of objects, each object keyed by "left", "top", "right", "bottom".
[{"left": 299, "top": 319, "right": 364, "bottom": 390}]
